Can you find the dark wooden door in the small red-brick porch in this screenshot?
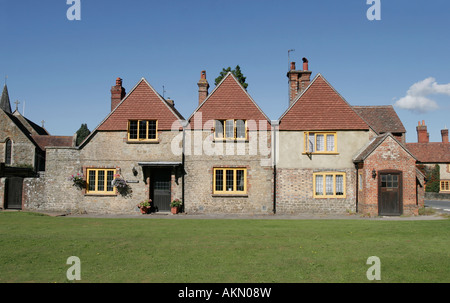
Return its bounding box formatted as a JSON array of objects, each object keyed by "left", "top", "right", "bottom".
[{"left": 378, "top": 172, "right": 403, "bottom": 216}]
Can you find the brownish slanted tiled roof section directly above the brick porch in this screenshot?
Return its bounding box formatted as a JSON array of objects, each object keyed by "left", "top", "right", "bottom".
[{"left": 352, "top": 105, "right": 406, "bottom": 134}]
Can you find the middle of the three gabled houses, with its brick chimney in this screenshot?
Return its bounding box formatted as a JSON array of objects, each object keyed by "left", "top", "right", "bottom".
[{"left": 185, "top": 71, "right": 273, "bottom": 214}]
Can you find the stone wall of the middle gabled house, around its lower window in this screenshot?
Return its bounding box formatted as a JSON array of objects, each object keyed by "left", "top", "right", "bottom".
[{"left": 185, "top": 131, "right": 273, "bottom": 214}]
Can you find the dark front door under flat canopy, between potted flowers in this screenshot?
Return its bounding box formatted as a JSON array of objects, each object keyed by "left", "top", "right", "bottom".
[{"left": 150, "top": 168, "right": 172, "bottom": 211}]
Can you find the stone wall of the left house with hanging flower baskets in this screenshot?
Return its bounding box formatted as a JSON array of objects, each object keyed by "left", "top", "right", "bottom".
[{"left": 27, "top": 131, "right": 182, "bottom": 214}]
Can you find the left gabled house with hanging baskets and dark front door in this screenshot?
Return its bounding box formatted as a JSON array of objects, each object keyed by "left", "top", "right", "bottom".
[{"left": 22, "top": 78, "right": 184, "bottom": 213}]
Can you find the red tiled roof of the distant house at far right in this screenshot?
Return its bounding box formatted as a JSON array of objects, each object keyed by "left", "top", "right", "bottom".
[{"left": 406, "top": 142, "right": 450, "bottom": 163}]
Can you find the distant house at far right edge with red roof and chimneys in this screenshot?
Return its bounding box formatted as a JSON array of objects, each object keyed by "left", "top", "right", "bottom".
[{"left": 406, "top": 121, "right": 450, "bottom": 194}]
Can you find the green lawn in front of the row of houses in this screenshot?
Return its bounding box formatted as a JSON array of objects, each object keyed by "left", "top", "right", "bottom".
[{"left": 0, "top": 212, "right": 450, "bottom": 283}]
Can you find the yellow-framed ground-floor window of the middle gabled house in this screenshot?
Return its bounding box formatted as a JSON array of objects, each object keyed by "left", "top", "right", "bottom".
[{"left": 213, "top": 167, "right": 247, "bottom": 195}]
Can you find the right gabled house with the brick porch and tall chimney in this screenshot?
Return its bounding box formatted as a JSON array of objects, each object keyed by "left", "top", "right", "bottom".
[{"left": 276, "top": 59, "right": 421, "bottom": 215}]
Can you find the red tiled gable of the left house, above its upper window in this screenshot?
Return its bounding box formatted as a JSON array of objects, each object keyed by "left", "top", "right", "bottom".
[{"left": 96, "top": 79, "right": 183, "bottom": 131}]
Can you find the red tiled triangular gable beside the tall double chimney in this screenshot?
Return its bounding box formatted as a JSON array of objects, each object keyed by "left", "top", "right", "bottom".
[{"left": 279, "top": 74, "right": 369, "bottom": 130}]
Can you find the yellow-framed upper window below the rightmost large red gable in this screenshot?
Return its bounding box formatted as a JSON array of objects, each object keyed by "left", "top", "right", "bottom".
[{"left": 303, "top": 132, "right": 337, "bottom": 154}]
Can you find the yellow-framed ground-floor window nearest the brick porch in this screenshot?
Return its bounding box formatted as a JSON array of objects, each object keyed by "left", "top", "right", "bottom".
[{"left": 313, "top": 172, "right": 346, "bottom": 198}]
